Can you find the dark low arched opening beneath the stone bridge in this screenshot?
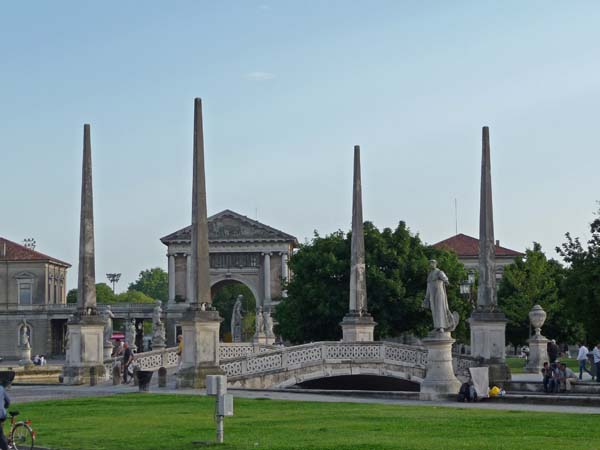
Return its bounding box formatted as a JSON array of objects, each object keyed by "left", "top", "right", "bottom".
[{"left": 293, "top": 375, "right": 421, "bottom": 392}]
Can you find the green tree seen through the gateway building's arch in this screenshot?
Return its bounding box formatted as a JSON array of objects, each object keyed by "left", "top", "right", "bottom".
[{"left": 213, "top": 282, "right": 256, "bottom": 340}]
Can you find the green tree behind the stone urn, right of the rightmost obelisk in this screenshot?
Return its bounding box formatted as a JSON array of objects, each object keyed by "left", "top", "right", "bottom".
[{"left": 498, "top": 242, "right": 577, "bottom": 345}]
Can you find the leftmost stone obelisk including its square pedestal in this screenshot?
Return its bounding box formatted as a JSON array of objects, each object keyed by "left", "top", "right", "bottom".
[{"left": 63, "top": 124, "right": 105, "bottom": 384}]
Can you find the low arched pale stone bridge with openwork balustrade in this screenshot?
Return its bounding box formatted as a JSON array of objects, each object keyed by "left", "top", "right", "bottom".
[{"left": 125, "top": 342, "right": 478, "bottom": 389}]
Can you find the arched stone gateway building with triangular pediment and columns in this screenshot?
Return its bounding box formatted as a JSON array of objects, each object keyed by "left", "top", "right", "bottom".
[{"left": 161, "top": 209, "right": 298, "bottom": 343}]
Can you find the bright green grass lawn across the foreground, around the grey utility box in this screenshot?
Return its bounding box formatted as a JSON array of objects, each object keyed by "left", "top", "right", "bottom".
[{"left": 8, "top": 394, "right": 600, "bottom": 450}]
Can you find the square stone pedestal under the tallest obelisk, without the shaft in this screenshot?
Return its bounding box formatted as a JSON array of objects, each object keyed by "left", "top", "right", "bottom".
[{"left": 176, "top": 309, "right": 223, "bottom": 388}]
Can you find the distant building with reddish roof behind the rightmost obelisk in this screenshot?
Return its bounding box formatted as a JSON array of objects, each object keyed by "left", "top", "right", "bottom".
[{"left": 433, "top": 233, "right": 523, "bottom": 278}]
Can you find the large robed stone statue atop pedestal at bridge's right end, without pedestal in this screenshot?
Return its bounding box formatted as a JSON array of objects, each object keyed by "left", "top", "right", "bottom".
[{"left": 422, "top": 259, "right": 459, "bottom": 332}]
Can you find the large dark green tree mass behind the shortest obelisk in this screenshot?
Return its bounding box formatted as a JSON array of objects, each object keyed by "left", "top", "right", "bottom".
[{"left": 275, "top": 222, "right": 471, "bottom": 343}]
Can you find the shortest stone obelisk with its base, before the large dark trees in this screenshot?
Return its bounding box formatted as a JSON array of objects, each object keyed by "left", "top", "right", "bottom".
[{"left": 340, "top": 145, "right": 376, "bottom": 342}]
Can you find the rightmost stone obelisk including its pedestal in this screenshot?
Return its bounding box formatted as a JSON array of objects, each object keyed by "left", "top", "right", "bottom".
[{"left": 469, "top": 127, "right": 510, "bottom": 382}]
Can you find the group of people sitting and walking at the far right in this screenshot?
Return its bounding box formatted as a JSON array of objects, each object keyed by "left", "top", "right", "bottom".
[{"left": 542, "top": 341, "right": 600, "bottom": 393}]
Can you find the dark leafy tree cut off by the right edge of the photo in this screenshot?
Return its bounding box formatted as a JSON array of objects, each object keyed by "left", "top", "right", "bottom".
[{"left": 556, "top": 211, "right": 600, "bottom": 344}]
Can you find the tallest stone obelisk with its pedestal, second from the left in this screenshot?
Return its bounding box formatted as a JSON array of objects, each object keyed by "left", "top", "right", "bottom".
[{"left": 177, "top": 98, "right": 222, "bottom": 388}]
